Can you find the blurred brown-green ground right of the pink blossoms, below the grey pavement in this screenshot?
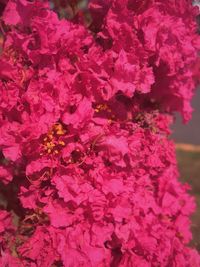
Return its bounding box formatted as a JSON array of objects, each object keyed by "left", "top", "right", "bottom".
[{"left": 177, "top": 149, "right": 200, "bottom": 251}]
